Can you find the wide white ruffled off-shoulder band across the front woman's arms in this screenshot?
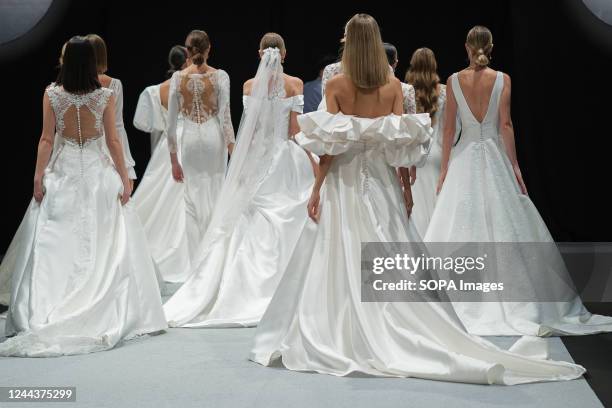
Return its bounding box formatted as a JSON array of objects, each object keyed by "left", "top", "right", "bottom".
[{"left": 295, "top": 111, "right": 433, "bottom": 167}]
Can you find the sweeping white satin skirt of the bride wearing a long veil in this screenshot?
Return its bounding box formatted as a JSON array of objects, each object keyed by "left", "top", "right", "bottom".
[{"left": 164, "top": 141, "right": 314, "bottom": 327}]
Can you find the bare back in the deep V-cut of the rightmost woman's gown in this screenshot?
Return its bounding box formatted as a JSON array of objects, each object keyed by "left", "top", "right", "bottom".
[{"left": 457, "top": 68, "right": 497, "bottom": 123}]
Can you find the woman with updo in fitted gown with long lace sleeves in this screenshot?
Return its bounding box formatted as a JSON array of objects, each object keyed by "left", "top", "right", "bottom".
[{"left": 167, "top": 30, "right": 235, "bottom": 265}]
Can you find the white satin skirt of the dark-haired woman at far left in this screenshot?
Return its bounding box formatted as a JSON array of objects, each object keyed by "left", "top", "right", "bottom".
[{"left": 0, "top": 140, "right": 167, "bottom": 357}]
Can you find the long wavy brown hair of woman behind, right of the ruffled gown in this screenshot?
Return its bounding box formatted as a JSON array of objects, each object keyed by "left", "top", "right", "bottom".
[{"left": 406, "top": 47, "right": 440, "bottom": 119}]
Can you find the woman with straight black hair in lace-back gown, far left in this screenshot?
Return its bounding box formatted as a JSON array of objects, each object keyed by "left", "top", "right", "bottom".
[{"left": 0, "top": 37, "right": 167, "bottom": 357}]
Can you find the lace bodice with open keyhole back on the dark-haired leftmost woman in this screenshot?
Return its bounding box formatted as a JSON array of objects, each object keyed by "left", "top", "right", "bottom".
[{"left": 46, "top": 85, "right": 113, "bottom": 145}]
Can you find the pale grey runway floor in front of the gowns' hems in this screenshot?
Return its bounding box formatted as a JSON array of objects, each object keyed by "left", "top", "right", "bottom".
[{"left": 0, "top": 320, "right": 610, "bottom": 408}]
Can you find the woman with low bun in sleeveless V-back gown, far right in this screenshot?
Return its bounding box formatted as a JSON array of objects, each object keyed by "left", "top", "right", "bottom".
[{"left": 425, "top": 26, "right": 612, "bottom": 336}]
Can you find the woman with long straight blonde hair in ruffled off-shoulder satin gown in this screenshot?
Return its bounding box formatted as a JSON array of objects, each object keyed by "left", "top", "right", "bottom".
[{"left": 250, "top": 14, "right": 584, "bottom": 384}]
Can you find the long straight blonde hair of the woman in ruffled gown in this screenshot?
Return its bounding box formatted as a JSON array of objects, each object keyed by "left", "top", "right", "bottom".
[{"left": 342, "top": 14, "right": 391, "bottom": 89}]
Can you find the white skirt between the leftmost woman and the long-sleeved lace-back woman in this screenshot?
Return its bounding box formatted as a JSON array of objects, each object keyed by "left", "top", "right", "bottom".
[{"left": 132, "top": 129, "right": 191, "bottom": 282}]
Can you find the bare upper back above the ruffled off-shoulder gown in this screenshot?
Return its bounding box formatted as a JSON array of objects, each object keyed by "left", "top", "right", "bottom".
[{"left": 325, "top": 74, "right": 404, "bottom": 118}]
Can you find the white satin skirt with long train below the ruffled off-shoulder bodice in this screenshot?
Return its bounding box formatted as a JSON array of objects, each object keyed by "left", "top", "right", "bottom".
[{"left": 250, "top": 150, "right": 584, "bottom": 384}]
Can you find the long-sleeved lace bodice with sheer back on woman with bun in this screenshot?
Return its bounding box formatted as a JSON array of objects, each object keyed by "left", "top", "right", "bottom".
[{"left": 168, "top": 69, "right": 235, "bottom": 152}]
